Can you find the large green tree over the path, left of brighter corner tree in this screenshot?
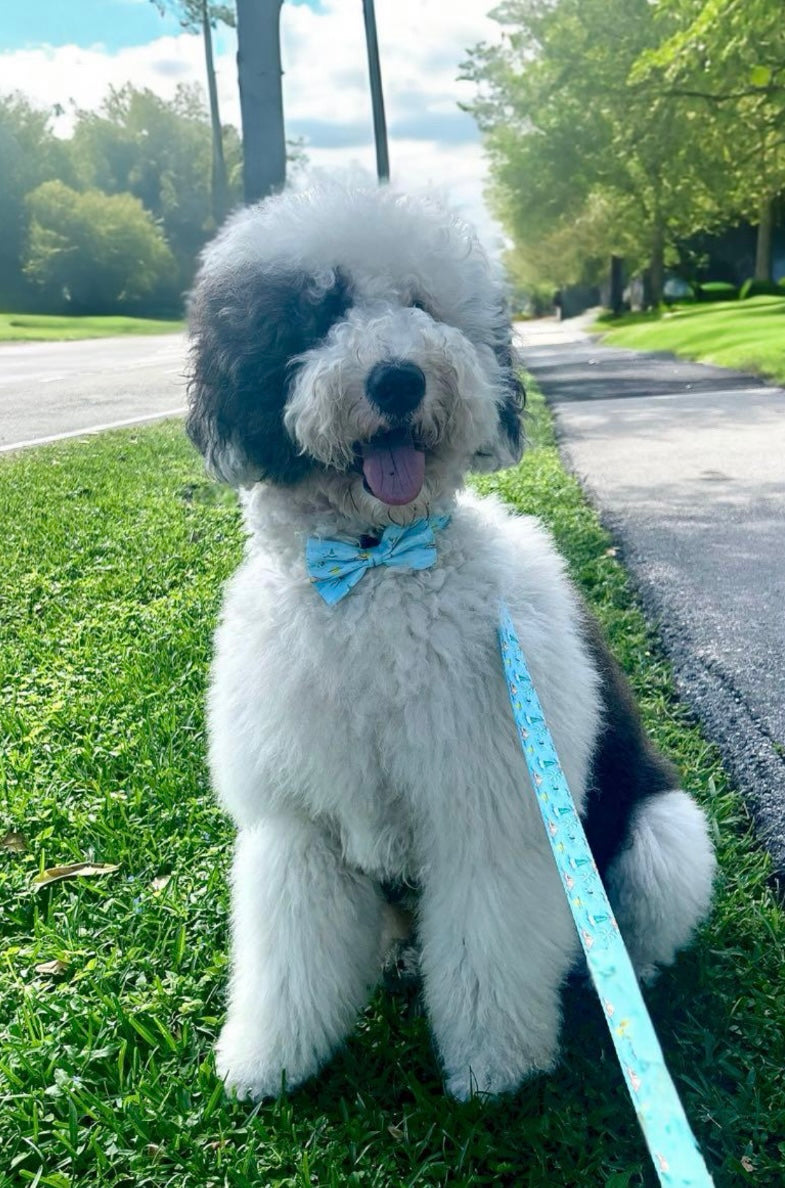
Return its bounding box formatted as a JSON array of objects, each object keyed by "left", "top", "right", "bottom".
[{"left": 467, "top": 0, "right": 785, "bottom": 301}]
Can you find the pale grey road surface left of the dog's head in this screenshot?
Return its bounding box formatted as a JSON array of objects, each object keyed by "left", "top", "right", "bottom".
[{"left": 0, "top": 334, "right": 185, "bottom": 453}]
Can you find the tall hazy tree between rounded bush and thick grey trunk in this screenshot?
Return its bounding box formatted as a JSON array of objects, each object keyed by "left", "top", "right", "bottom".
[{"left": 71, "top": 86, "right": 242, "bottom": 291}]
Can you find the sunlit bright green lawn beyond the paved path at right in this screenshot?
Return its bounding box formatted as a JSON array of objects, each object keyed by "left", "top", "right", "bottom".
[{"left": 594, "top": 296, "right": 785, "bottom": 384}]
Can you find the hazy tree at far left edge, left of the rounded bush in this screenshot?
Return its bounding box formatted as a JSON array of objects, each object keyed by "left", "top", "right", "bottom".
[{"left": 0, "top": 94, "right": 71, "bottom": 308}]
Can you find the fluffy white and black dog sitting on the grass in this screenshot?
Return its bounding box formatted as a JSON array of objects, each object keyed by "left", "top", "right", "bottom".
[{"left": 188, "top": 188, "right": 714, "bottom": 1099}]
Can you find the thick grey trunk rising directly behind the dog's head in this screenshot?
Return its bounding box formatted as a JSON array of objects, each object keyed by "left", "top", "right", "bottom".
[{"left": 236, "top": 0, "right": 286, "bottom": 202}]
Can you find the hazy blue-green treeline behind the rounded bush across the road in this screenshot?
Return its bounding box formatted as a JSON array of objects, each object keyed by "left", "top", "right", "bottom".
[{"left": 0, "top": 86, "right": 242, "bottom": 312}]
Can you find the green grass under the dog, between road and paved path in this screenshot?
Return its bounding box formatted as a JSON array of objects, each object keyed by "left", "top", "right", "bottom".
[{"left": 0, "top": 400, "right": 785, "bottom": 1188}]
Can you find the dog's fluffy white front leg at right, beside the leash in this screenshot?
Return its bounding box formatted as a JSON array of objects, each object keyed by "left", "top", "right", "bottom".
[{"left": 420, "top": 829, "right": 576, "bottom": 1100}]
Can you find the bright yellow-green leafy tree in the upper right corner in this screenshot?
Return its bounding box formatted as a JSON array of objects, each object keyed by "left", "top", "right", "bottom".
[{"left": 632, "top": 0, "right": 785, "bottom": 282}]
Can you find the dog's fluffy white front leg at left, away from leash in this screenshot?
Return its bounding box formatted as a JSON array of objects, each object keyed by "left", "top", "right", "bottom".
[{"left": 216, "top": 815, "right": 381, "bottom": 1100}]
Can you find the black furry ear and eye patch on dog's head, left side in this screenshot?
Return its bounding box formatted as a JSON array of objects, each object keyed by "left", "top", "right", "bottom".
[{"left": 185, "top": 258, "right": 350, "bottom": 486}]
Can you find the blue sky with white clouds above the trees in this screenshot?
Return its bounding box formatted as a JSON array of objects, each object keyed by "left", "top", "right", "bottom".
[{"left": 0, "top": 0, "right": 500, "bottom": 252}]
